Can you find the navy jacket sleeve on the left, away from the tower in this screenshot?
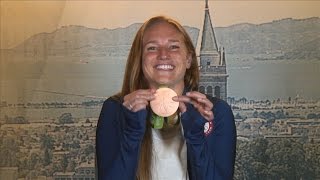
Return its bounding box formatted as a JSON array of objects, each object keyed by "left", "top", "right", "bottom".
[{"left": 96, "top": 98, "right": 147, "bottom": 180}]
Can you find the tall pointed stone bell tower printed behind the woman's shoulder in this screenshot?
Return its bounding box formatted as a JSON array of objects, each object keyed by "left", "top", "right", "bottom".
[{"left": 199, "top": 0, "right": 228, "bottom": 101}]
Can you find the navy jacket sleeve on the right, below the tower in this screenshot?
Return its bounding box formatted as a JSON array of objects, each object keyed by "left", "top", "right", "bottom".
[{"left": 181, "top": 100, "right": 236, "bottom": 180}]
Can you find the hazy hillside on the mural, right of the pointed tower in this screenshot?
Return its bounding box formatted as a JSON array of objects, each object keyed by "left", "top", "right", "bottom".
[{"left": 215, "top": 17, "right": 320, "bottom": 59}]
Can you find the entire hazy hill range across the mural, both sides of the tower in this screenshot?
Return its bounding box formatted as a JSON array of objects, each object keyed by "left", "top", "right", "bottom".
[{"left": 14, "top": 17, "right": 320, "bottom": 59}]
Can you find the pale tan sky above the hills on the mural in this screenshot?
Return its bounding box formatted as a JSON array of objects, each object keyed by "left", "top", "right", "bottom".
[{"left": 0, "top": 0, "right": 320, "bottom": 49}]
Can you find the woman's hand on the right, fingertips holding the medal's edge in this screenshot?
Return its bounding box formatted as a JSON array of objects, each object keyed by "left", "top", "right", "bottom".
[{"left": 172, "top": 91, "right": 213, "bottom": 121}]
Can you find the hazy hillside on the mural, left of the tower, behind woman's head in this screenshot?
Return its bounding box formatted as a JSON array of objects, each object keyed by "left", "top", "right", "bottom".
[{"left": 14, "top": 24, "right": 199, "bottom": 57}]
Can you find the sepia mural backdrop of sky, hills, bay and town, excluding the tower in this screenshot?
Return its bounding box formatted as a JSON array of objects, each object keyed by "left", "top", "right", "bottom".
[{"left": 0, "top": 0, "right": 320, "bottom": 180}]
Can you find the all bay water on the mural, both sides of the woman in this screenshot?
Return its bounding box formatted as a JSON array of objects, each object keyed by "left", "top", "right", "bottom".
[{"left": 0, "top": 56, "right": 320, "bottom": 103}]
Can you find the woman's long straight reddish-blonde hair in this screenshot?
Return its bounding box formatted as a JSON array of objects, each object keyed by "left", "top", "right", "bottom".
[{"left": 117, "top": 16, "right": 199, "bottom": 180}]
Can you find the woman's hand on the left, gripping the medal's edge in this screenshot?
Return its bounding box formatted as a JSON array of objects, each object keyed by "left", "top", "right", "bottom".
[{"left": 122, "top": 89, "right": 156, "bottom": 112}]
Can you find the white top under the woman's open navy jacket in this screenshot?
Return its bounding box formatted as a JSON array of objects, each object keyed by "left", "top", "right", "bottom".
[{"left": 151, "top": 127, "right": 189, "bottom": 180}]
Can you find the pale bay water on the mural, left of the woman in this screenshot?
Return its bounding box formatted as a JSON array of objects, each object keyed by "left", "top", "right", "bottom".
[{"left": 0, "top": 58, "right": 125, "bottom": 103}]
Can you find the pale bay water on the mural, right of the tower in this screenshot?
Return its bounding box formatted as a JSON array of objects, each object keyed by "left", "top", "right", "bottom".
[{"left": 227, "top": 56, "right": 320, "bottom": 100}]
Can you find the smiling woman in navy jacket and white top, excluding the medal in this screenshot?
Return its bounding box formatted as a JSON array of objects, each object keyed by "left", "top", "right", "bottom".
[{"left": 96, "top": 16, "right": 236, "bottom": 180}]
